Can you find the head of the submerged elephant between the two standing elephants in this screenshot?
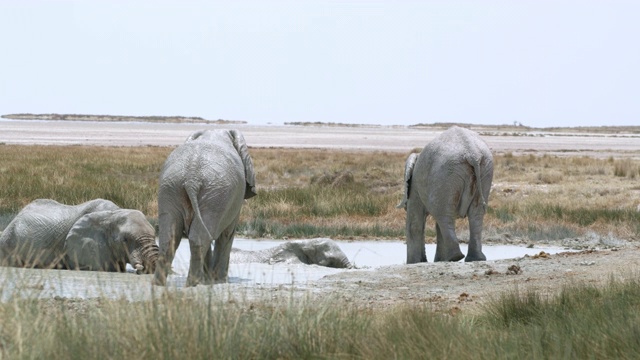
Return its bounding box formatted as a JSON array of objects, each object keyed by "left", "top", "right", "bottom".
[{"left": 270, "top": 239, "right": 353, "bottom": 268}]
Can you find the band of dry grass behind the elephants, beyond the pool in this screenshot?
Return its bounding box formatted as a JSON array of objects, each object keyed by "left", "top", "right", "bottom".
[{"left": 0, "top": 145, "right": 640, "bottom": 241}]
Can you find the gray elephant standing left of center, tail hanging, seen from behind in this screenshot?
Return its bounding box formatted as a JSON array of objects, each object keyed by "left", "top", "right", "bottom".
[{"left": 153, "top": 130, "right": 256, "bottom": 286}]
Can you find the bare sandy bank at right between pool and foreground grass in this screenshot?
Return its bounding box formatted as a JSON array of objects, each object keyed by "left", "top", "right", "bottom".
[{"left": 314, "top": 245, "right": 640, "bottom": 314}]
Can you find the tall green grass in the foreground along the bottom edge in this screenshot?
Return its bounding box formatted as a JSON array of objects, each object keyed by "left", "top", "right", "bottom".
[{"left": 0, "top": 280, "right": 640, "bottom": 359}]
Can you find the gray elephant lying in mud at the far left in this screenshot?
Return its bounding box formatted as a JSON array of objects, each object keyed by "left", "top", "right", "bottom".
[{"left": 0, "top": 199, "right": 158, "bottom": 274}]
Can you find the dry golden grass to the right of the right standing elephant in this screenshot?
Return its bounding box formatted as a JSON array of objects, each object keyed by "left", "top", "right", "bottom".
[{"left": 486, "top": 155, "right": 640, "bottom": 239}]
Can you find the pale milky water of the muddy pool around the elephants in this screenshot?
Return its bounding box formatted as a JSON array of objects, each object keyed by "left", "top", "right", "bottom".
[{"left": 0, "top": 239, "right": 564, "bottom": 301}]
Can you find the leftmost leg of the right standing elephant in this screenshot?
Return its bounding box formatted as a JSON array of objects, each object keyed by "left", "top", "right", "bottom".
[{"left": 406, "top": 196, "right": 427, "bottom": 264}]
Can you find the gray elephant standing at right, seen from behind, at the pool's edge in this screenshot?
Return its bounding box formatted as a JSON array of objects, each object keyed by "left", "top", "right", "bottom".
[{"left": 398, "top": 126, "right": 493, "bottom": 264}]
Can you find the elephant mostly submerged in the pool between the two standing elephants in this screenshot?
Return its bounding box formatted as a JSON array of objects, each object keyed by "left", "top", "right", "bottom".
[{"left": 231, "top": 239, "right": 353, "bottom": 269}]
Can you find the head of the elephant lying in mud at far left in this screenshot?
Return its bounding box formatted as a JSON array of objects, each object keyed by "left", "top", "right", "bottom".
[{"left": 65, "top": 209, "right": 158, "bottom": 274}]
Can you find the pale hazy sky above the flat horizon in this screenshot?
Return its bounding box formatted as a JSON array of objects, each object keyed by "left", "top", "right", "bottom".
[{"left": 0, "top": 0, "right": 640, "bottom": 127}]
